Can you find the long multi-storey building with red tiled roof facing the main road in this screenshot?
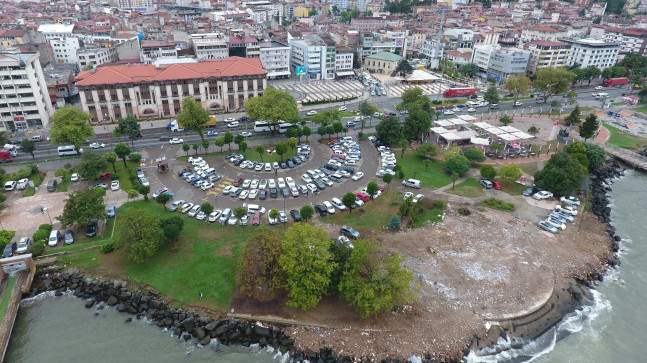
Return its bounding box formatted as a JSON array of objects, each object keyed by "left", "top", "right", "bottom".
[{"left": 76, "top": 57, "right": 267, "bottom": 124}]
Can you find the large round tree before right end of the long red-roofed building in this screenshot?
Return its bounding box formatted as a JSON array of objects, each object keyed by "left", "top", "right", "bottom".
[{"left": 245, "top": 88, "right": 299, "bottom": 133}]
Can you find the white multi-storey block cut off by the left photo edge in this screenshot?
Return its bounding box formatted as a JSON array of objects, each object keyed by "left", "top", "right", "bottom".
[{"left": 0, "top": 48, "right": 54, "bottom": 132}]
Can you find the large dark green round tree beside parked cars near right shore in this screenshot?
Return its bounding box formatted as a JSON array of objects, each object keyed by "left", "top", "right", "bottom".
[{"left": 535, "top": 152, "right": 586, "bottom": 195}]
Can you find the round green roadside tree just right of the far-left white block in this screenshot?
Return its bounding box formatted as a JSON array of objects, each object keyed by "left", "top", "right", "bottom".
[{"left": 49, "top": 104, "right": 94, "bottom": 151}]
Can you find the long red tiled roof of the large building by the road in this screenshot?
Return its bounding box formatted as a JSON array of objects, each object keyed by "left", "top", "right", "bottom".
[{"left": 76, "top": 57, "right": 267, "bottom": 86}]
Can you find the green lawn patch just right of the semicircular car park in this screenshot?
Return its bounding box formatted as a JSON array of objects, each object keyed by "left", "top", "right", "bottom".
[{"left": 394, "top": 150, "right": 453, "bottom": 188}]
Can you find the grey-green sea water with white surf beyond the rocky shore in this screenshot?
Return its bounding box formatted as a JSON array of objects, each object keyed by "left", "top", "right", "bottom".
[{"left": 5, "top": 171, "right": 647, "bottom": 363}]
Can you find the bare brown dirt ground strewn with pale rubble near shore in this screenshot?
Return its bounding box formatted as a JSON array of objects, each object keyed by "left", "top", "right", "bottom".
[{"left": 232, "top": 205, "right": 609, "bottom": 359}]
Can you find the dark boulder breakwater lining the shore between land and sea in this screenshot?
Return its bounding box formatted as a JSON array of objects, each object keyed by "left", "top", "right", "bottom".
[{"left": 22, "top": 159, "right": 622, "bottom": 362}]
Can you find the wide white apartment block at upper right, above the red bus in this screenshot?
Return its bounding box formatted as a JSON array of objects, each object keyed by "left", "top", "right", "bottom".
[{"left": 561, "top": 38, "right": 620, "bottom": 70}]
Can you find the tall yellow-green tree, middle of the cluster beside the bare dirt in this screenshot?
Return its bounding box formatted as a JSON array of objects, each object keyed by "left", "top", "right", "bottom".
[{"left": 279, "top": 223, "right": 336, "bottom": 310}]
